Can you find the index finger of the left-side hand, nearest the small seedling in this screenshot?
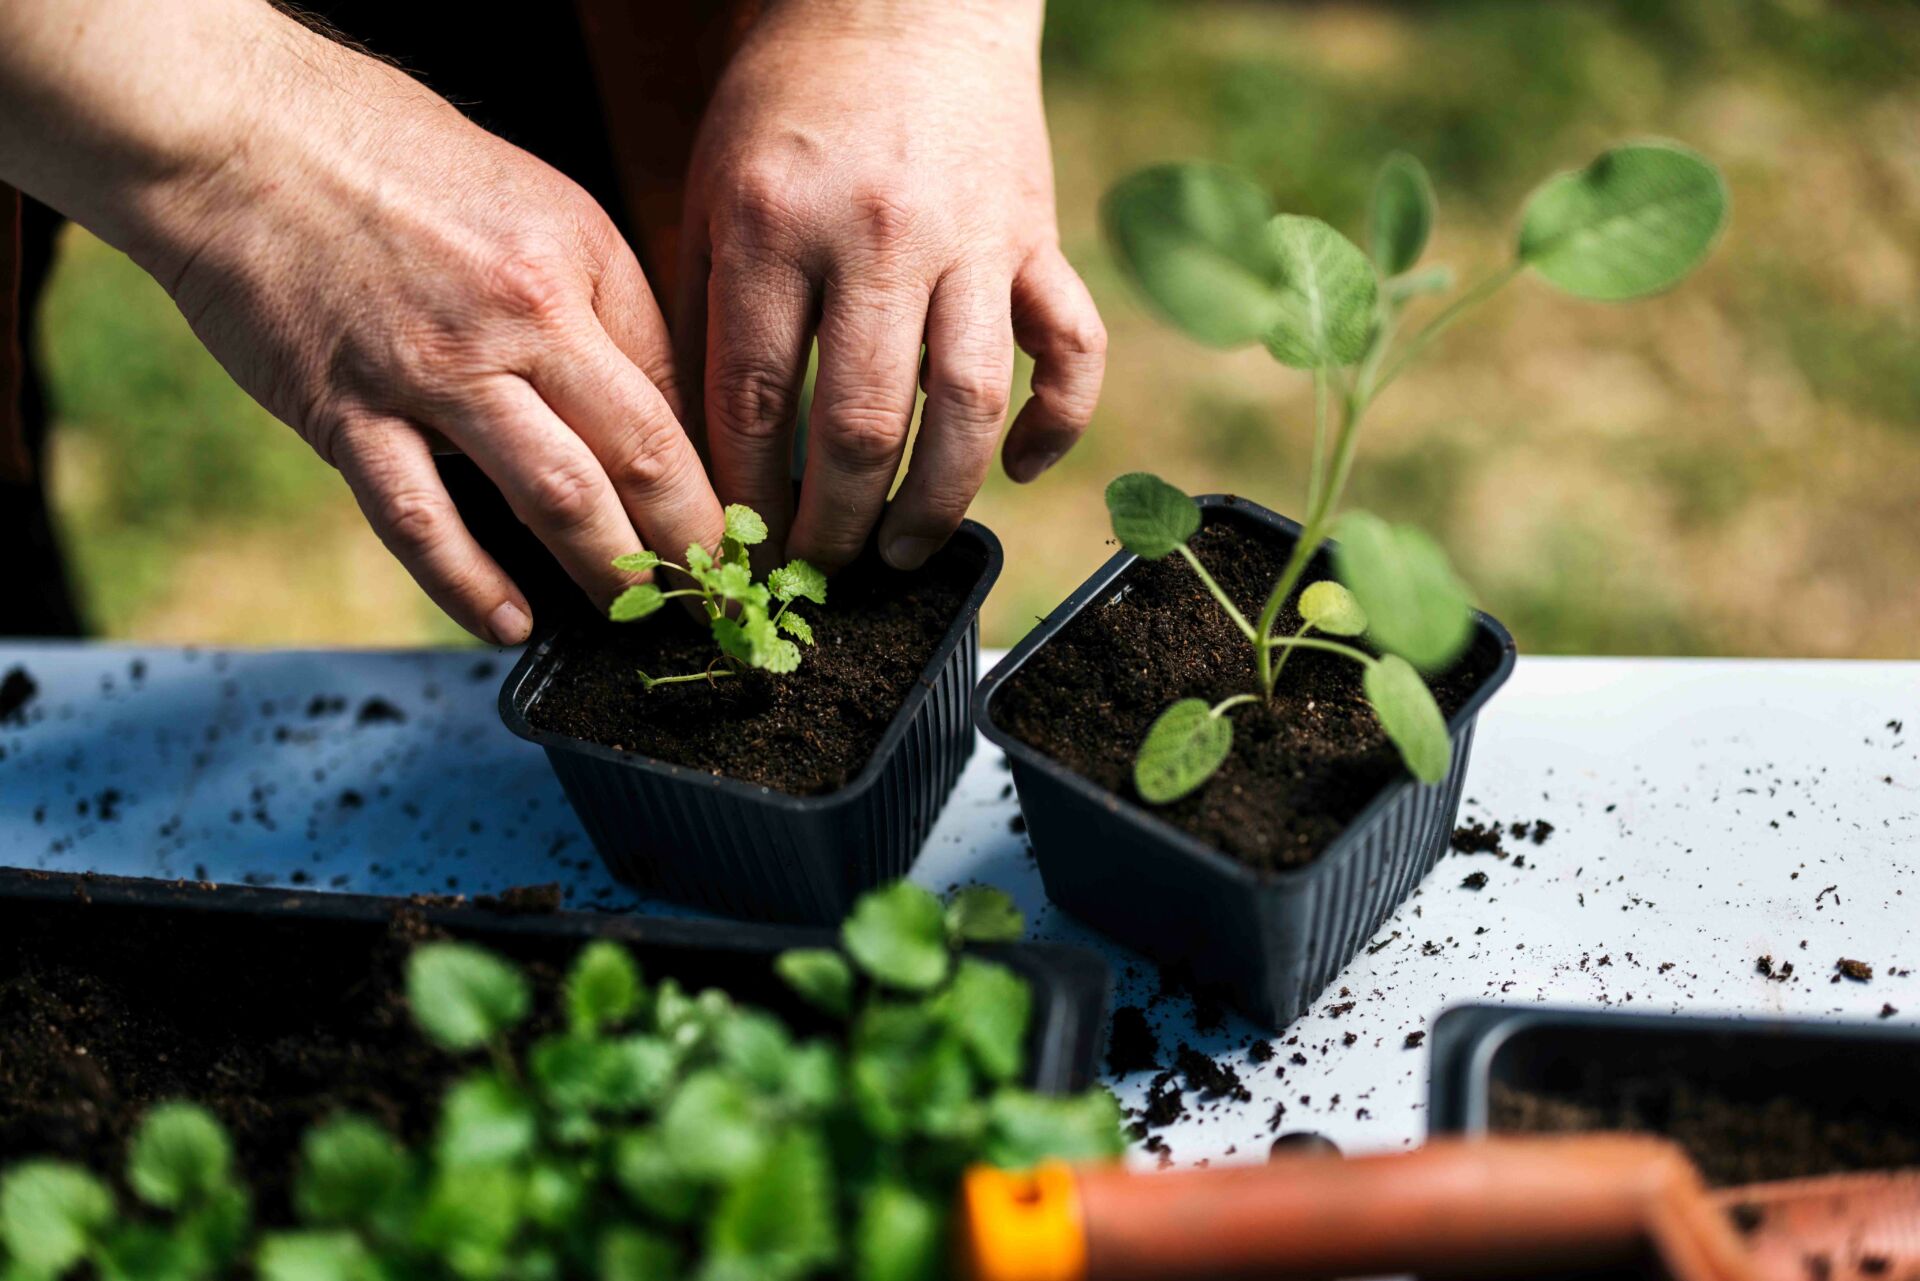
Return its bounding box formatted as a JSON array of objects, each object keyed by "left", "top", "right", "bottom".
[{"left": 534, "top": 326, "right": 724, "bottom": 572}]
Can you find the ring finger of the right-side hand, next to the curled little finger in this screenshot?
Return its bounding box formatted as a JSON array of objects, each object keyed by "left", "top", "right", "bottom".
[{"left": 879, "top": 273, "right": 1014, "bottom": 568}]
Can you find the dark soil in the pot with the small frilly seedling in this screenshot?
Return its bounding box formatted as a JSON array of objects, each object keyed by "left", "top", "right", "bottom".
[{"left": 528, "top": 544, "right": 983, "bottom": 795}]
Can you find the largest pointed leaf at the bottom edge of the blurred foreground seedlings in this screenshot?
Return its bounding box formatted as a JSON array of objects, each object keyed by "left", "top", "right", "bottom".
[{"left": 707, "top": 1129, "right": 839, "bottom": 1279}]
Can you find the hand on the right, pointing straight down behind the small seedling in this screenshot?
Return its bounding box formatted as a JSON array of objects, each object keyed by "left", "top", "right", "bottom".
[{"left": 674, "top": 0, "right": 1106, "bottom": 568}]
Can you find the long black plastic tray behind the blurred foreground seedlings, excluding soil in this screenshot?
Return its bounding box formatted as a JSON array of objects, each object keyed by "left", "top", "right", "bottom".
[{"left": 0, "top": 868, "right": 1112, "bottom": 1093}]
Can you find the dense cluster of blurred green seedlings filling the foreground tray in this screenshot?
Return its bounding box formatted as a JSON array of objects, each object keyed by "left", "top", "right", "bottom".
[{"left": 0, "top": 883, "right": 1121, "bottom": 1281}]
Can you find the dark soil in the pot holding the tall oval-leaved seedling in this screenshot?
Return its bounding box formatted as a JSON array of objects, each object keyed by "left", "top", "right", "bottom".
[{"left": 993, "top": 517, "right": 1498, "bottom": 870}]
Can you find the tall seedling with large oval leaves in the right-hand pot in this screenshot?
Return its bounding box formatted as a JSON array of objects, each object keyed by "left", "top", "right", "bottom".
[{"left": 1102, "top": 142, "right": 1726, "bottom": 805}]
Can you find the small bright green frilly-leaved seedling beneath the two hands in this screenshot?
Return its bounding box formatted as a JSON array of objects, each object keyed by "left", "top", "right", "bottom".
[{"left": 607, "top": 503, "right": 828, "bottom": 689}]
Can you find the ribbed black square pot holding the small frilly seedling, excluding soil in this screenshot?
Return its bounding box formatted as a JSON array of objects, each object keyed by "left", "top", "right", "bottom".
[{"left": 499, "top": 520, "right": 1000, "bottom": 924}]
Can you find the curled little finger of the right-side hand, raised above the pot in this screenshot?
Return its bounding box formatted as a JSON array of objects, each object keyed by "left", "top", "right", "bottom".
[{"left": 1004, "top": 250, "right": 1106, "bottom": 484}]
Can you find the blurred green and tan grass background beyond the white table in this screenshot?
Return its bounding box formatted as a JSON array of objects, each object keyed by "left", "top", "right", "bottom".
[{"left": 44, "top": 0, "right": 1920, "bottom": 657}]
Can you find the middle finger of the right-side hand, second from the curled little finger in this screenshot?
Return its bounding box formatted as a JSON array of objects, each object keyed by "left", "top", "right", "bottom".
[{"left": 787, "top": 282, "right": 927, "bottom": 572}]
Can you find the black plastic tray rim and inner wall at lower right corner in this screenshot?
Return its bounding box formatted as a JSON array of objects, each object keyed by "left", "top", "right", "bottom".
[{"left": 1427, "top": 1004, "right": 1920, "bottom": 1135}]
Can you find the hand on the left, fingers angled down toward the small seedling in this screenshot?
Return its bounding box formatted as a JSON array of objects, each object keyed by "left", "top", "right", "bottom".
[{"left": 129, "top": 15, "right": 722, "bottom": 645}]
